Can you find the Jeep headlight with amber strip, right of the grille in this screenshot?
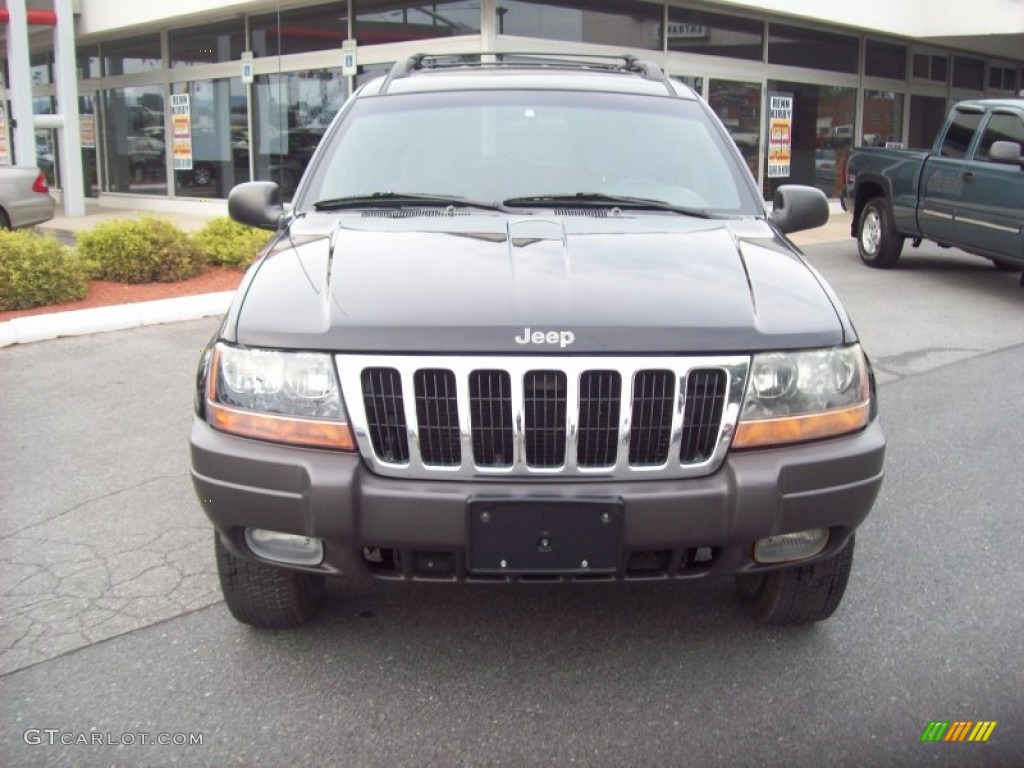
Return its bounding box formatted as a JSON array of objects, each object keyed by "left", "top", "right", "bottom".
[{"left": 732, "top": 344, "right": 869, "bottom": 449}]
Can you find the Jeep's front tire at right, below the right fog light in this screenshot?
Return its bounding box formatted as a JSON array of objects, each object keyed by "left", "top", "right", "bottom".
[{"left": 736, "top": 537, "right": 854, "bottom": 625}]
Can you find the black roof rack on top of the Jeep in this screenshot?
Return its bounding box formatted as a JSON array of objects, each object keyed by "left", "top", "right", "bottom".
[{"left": 380, "top": 51, "right": 676, "bottom": 96}]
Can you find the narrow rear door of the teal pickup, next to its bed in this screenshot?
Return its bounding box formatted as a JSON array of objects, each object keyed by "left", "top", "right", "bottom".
[{"left": 918, "top": 105, "right": 984, "bottom": 244}]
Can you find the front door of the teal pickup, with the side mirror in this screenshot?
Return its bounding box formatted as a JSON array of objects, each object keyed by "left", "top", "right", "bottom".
[{"left": 956, "top": 109, "right": 1024, "bottom": 261}]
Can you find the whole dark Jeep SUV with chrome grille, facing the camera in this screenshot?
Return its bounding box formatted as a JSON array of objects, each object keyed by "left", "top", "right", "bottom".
[{"left": 191, "top": 55, "right": 885, "bottom": 627}]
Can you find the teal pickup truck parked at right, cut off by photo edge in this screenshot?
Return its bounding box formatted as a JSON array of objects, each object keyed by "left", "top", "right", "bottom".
[{"left": 843, "top": 98, "right": 1024, "bottom": 286}]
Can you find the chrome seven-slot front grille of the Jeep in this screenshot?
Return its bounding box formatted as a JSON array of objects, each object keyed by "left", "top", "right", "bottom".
[{"left": 337, "top": 355, "right": 749, "bottom": 479}]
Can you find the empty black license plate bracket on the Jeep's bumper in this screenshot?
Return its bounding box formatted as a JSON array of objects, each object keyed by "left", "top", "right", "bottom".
[{"left": 466, "top": 498, "right": 625, "bottom": 574}]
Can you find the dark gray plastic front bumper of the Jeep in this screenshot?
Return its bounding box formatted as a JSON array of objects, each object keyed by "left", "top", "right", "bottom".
[{"left": 191, "top": 417, "right": 885, "bottom": 581}]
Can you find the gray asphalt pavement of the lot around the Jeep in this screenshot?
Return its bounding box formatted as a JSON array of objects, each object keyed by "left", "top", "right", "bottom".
[{"left": 0, "top": 242, "right": 1024, "bottom": 766}]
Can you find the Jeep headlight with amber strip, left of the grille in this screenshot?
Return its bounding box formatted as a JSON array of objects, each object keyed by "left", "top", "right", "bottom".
[{"left": 207, "top": 343, "right": 355, "bottom": 451}]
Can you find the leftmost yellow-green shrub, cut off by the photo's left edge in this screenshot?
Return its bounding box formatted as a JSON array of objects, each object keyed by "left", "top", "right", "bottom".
[{"left": 0, "top": 231, "right": 89, "bottom": 310}]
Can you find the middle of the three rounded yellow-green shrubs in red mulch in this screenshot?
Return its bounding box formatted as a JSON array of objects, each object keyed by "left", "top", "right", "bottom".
[{"left": 77, "top": 216, "right": 206, "bottom": 283}]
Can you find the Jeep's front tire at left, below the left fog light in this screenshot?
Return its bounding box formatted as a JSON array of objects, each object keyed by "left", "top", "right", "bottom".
[{"left": 214, "top": 534, "right": 324, "bottom": 629}]
